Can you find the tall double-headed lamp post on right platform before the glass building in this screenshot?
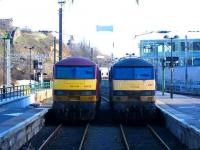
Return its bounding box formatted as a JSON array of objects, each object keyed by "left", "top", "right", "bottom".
[{"left": 164, "top": 35, "right": 179, "bottom": 99}]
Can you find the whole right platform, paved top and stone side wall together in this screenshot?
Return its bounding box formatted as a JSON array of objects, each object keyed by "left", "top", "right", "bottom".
[{"left": 156, "top": 92, "right": 200, "bottom": 149}]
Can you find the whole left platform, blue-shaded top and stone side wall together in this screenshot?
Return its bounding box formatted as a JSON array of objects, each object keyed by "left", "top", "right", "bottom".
[{"left": 0, "top": 107, "right": 48, "bottom": 150}]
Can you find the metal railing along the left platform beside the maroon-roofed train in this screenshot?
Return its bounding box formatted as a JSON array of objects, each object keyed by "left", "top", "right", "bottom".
[{"left": 0, "top": 82, "right": 52, "bottom": 102}]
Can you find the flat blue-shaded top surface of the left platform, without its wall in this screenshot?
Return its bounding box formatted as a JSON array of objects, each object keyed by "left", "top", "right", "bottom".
[{"left": 0, "top": 107, "right": 48, "bottom": 138}]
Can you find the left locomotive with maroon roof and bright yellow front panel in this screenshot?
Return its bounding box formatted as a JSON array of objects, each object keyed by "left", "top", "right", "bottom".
[{"left": 53, "top": 57, "right": 100, "bottom": 120}]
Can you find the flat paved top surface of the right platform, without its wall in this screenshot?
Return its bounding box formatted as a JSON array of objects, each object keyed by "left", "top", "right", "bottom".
[{"left": 156, "top": 92, "right": 200, "bottom": 129}]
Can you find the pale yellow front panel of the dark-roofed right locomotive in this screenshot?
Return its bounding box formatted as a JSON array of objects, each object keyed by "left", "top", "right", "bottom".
[{"left": 113, "top": 80, "right": 155, "bottom": 91}]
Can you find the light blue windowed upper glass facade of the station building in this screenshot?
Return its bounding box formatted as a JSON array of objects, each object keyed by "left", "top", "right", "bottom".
[{"left": 139, "top": 39, "right": 200, "bottom": 66}]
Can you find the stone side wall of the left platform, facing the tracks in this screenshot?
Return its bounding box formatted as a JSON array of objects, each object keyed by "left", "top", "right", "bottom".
[{"left": 0, "top": 109, "right": 47, "bottom": 150}]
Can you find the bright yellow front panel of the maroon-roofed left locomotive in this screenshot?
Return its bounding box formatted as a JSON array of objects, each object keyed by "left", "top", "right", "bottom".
[{"left": 53, "top": 79, "right": 97, "bottom": 90}]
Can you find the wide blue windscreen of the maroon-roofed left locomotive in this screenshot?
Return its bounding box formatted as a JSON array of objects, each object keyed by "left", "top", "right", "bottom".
[{"left": 55, "top": 66, "right": 94, "bottom": 79}]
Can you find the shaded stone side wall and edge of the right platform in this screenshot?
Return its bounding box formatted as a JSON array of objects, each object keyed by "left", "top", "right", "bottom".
[{"left": 156, "top": 101, "right": 200, "bottom": 149}]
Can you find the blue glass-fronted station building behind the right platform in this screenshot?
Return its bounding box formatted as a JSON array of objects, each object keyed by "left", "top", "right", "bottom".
[{"left": 139, "top": 32, "right": 200, "bottom": 94}]
